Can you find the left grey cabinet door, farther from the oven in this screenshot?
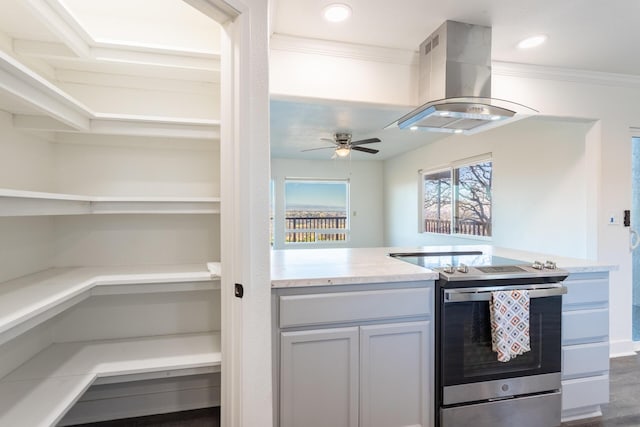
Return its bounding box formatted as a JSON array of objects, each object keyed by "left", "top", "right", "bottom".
[{"left": 280, "top": 327, "right": 358, "bottom": 427}]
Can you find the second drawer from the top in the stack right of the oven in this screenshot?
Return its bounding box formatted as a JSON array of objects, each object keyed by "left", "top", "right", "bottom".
[{"left": 562, "top": 308, "right": 609, "bottom": 344}]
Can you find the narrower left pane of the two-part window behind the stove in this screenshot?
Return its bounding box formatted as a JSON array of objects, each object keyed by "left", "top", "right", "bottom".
[{"left": 423, "top": 170, "right": 451, "bottom": 234}]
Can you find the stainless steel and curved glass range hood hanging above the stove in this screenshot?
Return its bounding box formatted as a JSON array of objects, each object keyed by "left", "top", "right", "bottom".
[{"left": 387, "top": 21, "right": 537, "bottom": 135}]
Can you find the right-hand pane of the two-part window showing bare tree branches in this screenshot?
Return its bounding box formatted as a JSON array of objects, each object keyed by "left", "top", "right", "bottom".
[{"left": 454, "top": 162, "right": 492, "bottom": 236}]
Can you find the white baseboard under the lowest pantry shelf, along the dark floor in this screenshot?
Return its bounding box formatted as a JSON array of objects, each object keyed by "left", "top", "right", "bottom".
[{"left": 58, "top": 374, "right": 221, "bottom": 427}]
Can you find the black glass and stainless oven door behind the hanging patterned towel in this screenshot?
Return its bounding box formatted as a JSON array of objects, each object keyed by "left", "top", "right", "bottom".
[{"left": 439, "top": 284, "right": 566, "bottom": 405}]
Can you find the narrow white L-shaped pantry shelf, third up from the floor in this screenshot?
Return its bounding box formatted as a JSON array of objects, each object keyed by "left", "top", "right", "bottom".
[{"left": 0, "top": 189, "right": 220, "bottom": 216}]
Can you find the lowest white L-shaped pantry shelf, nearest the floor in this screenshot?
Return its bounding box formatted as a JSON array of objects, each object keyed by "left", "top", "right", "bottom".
[{"left": 0, "top": 332, "right": 221, "bottom": 427}]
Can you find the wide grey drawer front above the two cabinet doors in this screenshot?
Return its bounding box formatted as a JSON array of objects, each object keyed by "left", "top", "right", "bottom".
[{"left": 279, "top": 287, "right": 433, "bottom": 328}]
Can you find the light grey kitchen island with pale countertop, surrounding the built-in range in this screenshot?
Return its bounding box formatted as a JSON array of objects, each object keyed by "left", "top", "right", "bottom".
[{"left": 271, "top": 245, "right": 613, "bottom": 427}]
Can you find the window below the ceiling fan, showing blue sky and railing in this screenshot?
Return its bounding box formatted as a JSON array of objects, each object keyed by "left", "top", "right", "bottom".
[{"left": 284, "top": 179, "right": 349, "bottom": 244}]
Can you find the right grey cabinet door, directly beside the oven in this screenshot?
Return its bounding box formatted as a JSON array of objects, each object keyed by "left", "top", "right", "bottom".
[{"left": 360, "top": 321, "right": 433, "bottom": 427}]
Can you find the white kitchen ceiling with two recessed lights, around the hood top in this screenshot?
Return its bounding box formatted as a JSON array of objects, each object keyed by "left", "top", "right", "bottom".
[{"left": 272, "top": 0, "right": 640, "bottom": 75}]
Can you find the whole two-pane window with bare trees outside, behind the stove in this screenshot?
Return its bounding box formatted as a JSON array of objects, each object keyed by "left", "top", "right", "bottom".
[{"left": 421, "top": 155, "right": 492, "bottom": 237}]
